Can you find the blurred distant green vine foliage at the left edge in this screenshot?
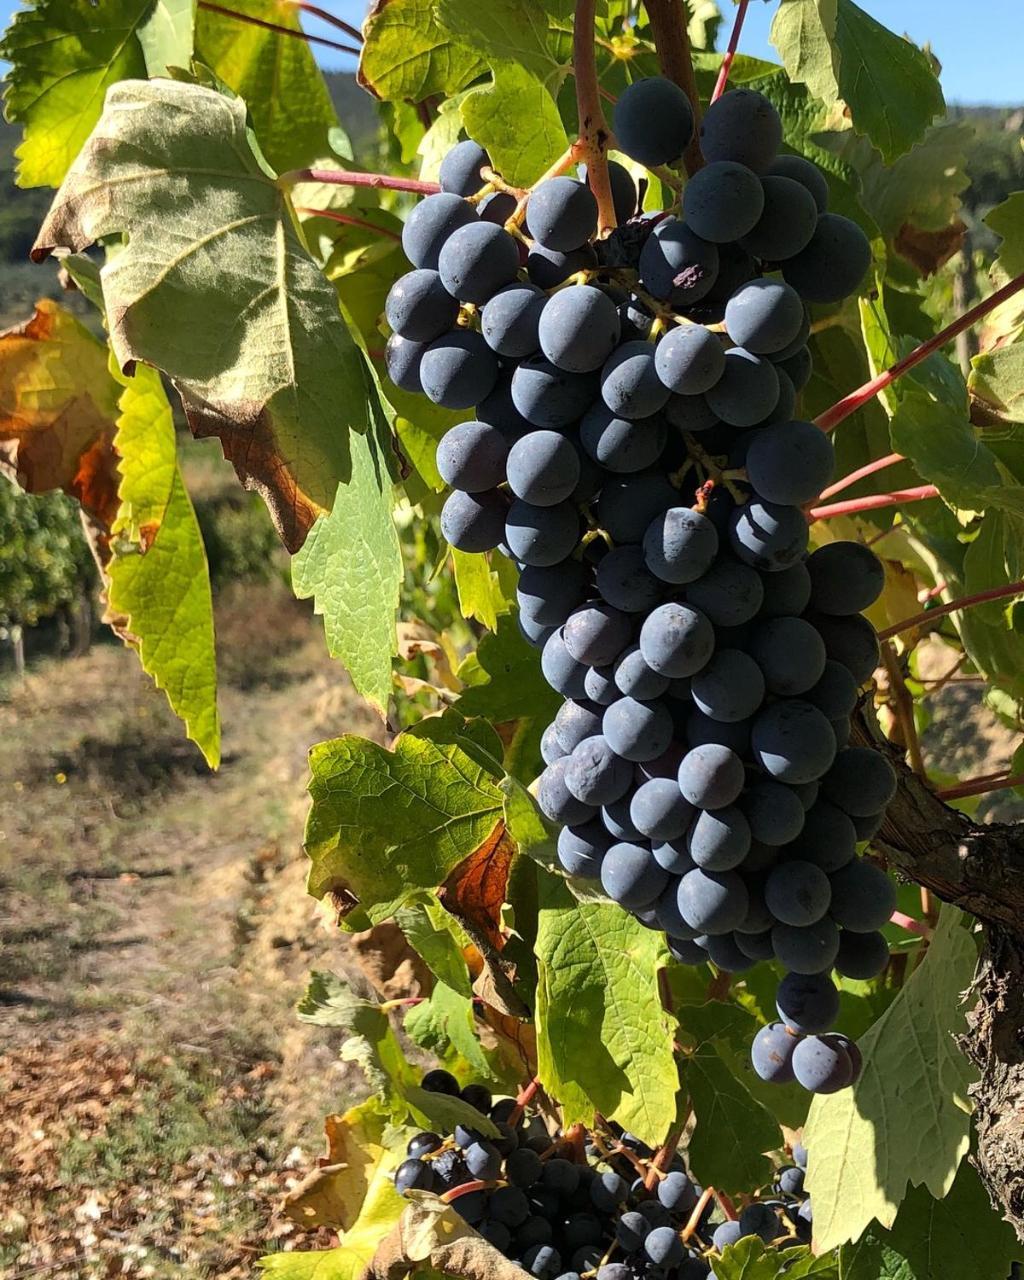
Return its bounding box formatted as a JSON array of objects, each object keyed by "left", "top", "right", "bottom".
[{"left": 0, "top": 479, "right": 96, "bottom": 627}]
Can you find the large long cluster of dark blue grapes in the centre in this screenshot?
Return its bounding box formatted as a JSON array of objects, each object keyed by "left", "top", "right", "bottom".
[{"left": 387, "top": 78, "right": 895, "bottom": 1092}]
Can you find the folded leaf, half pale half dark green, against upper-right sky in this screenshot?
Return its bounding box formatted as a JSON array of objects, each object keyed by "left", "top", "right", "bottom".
[{"left": 772, "top": 0, "right": 945, "bottom": 164}]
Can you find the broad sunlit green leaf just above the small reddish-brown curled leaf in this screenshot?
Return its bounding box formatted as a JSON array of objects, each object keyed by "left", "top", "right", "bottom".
[{"left": 306, "top": 727, "right": 502, "bottom": 922}]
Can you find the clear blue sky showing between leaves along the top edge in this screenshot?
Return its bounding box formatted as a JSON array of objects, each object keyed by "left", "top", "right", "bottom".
[{"left": 0, "top": 0, "right": 1024, "bottom": 105}]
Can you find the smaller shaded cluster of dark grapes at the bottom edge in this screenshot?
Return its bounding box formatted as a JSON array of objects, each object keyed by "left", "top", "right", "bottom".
[{"left": 394, "top": 1070, "right": 810, "bottom": 1280}]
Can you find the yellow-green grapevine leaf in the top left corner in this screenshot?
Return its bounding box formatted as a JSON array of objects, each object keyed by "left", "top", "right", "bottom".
[{"left": 0, "top": 0, "right": 151, "bottom": 187}]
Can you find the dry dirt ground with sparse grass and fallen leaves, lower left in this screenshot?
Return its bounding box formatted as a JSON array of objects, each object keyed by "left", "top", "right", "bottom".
[{"left": 0, "top": 585, "right": 380, "bottom": 1280}]
